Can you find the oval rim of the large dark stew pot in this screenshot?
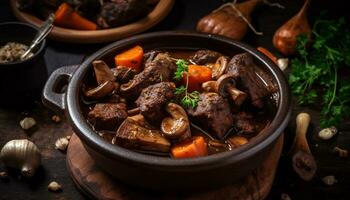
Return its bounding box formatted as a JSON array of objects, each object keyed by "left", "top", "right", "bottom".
[{"left": 66, "top": 31, "right": 291, "bottom": 168}]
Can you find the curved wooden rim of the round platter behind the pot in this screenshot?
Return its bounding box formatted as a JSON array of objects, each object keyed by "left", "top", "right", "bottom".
[{"left": 10, "top": 0, "right": 175, "bottom": 43}]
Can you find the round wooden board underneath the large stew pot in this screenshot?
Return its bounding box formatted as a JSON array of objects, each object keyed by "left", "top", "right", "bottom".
[{"left": 66, "top": 134, "right": 283, "bottom": 200}]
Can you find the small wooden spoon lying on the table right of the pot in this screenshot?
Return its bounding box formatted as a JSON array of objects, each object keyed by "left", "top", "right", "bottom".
[{"left": 292, "top": 113, "right": 317, "bottom": 181}]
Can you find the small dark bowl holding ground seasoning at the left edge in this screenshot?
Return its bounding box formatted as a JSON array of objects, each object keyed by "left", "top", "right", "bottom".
[{"left": 0, "top": 22, "right": 48, "bottom": 106}]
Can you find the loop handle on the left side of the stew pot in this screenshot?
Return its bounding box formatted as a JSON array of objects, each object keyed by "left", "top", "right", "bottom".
[{"left": 41, "top": 65, "right": 79, "bottom": 114}]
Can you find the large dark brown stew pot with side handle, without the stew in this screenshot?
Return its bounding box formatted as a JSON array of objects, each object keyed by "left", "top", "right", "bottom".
[{"left": 43, "top": 32, "right": 291, "bottom": 191}]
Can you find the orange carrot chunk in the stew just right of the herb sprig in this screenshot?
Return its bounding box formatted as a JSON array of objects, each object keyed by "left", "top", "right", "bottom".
[{"left": 183, "top": 65, "right": 211, "bottom": 92}]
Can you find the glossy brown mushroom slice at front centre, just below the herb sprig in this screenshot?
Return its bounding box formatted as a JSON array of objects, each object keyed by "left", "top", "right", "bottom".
[{"left": 161, "top": 103, "right": 191, "bottom": 139}]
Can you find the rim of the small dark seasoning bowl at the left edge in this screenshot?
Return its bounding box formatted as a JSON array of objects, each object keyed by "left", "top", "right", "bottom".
[{"left": 0, "top": 22, "right": 46, "bottom": 67}]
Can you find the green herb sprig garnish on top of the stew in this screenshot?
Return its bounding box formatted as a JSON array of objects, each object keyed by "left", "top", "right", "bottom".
[{"left": 174, "top": 59, "right": 200, "bottom": 108}]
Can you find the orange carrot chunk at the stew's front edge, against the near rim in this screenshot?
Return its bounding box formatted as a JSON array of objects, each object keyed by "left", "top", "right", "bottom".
[{"left": 170, "top": 136, "right": 208, "bottom": 158}]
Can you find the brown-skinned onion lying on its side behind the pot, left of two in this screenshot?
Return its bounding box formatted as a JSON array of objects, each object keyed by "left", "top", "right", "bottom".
[{"left": 196, "top": 0, "right": 262, "bottom": 40}]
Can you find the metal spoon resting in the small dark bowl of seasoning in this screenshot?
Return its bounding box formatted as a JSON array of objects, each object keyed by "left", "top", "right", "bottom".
[{"left": 21, "top": 13, "right": 55, "bottom": 60}]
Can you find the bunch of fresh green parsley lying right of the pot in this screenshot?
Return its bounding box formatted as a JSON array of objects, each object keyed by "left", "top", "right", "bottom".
[{"left": 289, "top": 18, "right": 350, "bottom": 127}]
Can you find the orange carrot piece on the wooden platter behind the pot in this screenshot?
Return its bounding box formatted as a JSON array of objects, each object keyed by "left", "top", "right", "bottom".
[{"left": 54, "top": 3, "right": 97, "bottom": 30}]
